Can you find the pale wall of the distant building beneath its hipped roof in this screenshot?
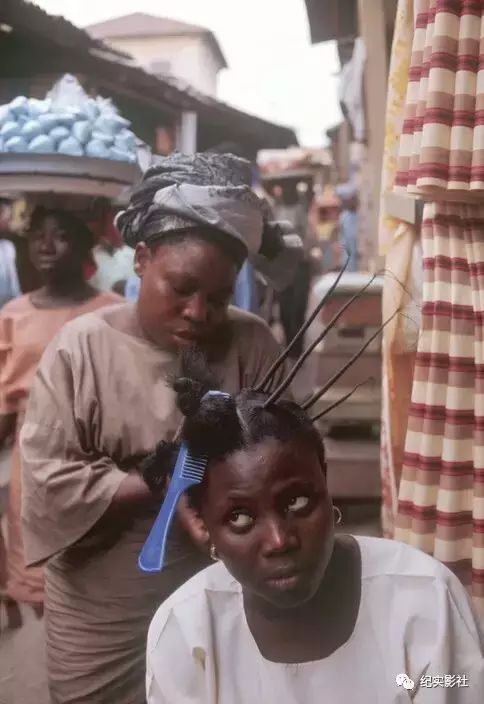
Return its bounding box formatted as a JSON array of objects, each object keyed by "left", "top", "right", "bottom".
[{"left": 107, "top": 36, "right": 221, "bottom": 97}]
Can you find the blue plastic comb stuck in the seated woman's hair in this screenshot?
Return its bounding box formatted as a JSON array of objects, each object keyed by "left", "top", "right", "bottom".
[{"left": 138, "top": 391, "right": 230, "bottom": 572}]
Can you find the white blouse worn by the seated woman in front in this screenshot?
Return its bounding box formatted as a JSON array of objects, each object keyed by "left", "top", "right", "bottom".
[{"left": 146, "top": 537, "right": 484, "bottom": 704}]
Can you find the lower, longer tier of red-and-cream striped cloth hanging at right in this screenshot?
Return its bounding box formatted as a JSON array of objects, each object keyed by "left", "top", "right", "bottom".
[{"left": 395, "top": 203, "right": 484, "bottom": 614}]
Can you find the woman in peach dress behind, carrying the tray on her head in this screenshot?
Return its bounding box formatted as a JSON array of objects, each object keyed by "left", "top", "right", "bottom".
[{"left": 0, "top": 206, "right": 121, "bottom": 704}]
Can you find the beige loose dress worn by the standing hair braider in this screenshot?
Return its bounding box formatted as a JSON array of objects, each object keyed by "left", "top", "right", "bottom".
[{"left": 21, "top": 305, "right": 286, "bottom": 704}]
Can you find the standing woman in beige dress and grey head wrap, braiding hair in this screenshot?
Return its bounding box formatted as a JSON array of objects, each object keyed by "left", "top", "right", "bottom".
[{"left": 18, "top": 154, "right": 298, "bottom": 704}]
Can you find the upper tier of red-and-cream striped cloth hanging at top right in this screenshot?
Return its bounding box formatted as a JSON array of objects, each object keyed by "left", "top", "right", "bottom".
[{"left": 395, "top": 0, "right": 484, "bottom": 202}]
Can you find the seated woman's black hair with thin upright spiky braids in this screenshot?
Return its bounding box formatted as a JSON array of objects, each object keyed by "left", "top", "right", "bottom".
[{"left": 142, "top": 256, "right": 399, "bottom": 496}]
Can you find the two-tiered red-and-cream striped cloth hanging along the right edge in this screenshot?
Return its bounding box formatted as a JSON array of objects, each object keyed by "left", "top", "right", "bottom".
[{"left": 395, "top": 0, "right": 484, "bottom": 614}]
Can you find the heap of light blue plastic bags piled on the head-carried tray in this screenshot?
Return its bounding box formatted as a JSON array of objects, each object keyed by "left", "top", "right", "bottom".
[{"left": 0, "top": 75, "right": 137, "bottom": 163}]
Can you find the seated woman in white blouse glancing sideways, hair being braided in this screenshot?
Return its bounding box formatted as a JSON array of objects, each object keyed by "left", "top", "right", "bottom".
[{"left": 144, "top": 340, "right": 484, "bottom": 704}]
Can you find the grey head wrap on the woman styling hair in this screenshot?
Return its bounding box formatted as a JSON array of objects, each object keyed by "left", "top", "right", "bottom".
[{"left": 116, "top": 153, "right": 302, "bottom": 290}]
